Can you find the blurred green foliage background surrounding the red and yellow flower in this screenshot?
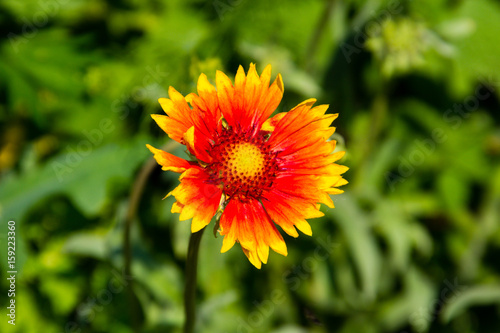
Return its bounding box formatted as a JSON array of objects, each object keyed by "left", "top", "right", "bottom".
[{"left": 0, "top": 0, "right": 500, "bottom": 333}]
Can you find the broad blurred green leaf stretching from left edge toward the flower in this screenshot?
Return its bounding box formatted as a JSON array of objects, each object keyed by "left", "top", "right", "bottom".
[{"left": 0, "top": 137, "right": 149, "bottom": 270}]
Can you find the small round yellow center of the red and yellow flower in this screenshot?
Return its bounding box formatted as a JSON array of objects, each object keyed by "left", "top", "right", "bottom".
[{"left": 227, "top": 142, "right": 265, "bottom": 178}]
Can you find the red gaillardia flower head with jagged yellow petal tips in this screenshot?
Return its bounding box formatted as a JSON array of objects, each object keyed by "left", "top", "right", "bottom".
[{"left": 147, "top": 64, "right": 348, "bottom": 268}]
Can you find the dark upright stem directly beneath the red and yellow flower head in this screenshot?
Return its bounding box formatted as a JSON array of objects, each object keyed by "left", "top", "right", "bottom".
[{"left": 184, "top": 228, "right": 205, "bottom": 333}]
